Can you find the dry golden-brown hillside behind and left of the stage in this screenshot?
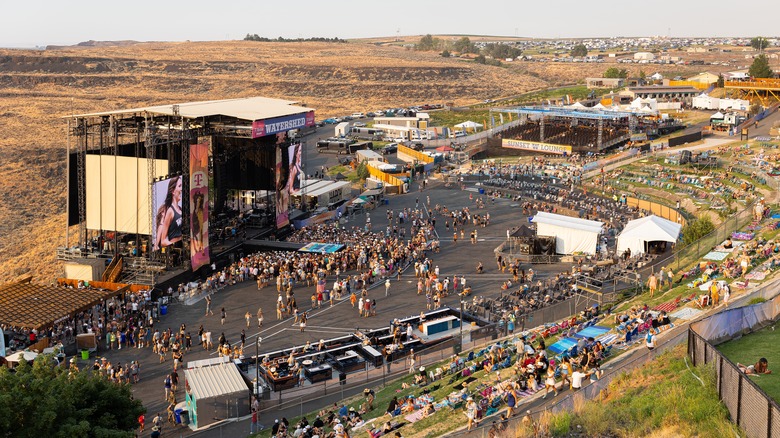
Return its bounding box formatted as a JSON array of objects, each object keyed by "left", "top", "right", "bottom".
[{"left": 0, "top": 41, "right": 547, "bottom": 282}]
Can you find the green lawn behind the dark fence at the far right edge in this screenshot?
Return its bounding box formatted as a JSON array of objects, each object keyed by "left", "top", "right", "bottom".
[{"left": 718, "top": 325, "right": 780, "bottom": 401}]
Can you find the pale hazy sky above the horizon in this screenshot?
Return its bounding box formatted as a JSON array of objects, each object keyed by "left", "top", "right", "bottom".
[{"left": 0, "top": 0, "right": 780, "bottom": 48}]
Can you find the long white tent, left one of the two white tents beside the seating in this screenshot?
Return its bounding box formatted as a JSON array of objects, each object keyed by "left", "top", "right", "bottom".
[{"left": 532, "top": 211, "right": 604, "bottom": 254}]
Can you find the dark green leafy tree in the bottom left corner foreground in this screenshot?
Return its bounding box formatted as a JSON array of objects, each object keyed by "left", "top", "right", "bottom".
[{"left": 0, "top": 355, "right": 145, "bottom": 438}]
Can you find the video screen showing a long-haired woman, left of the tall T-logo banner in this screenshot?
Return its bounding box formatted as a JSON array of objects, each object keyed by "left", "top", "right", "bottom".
[{"left": 152, "top": 176, "right": 182, "bottom": 251}]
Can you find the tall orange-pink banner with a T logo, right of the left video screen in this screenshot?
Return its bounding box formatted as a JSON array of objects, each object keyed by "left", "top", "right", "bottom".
[{"left": 190, "top": 143, "right": 210, "bottom": 271}]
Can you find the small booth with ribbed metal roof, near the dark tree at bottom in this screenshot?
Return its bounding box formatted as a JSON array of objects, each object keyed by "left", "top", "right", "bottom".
[{"left": 184, "top": 357, "right": 251, "bottom": 430}]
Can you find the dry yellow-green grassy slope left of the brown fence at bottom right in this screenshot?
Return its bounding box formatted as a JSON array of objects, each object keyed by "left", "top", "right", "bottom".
[{"left": 549, "top": 346, "right": 744, "bottom": 437}]
